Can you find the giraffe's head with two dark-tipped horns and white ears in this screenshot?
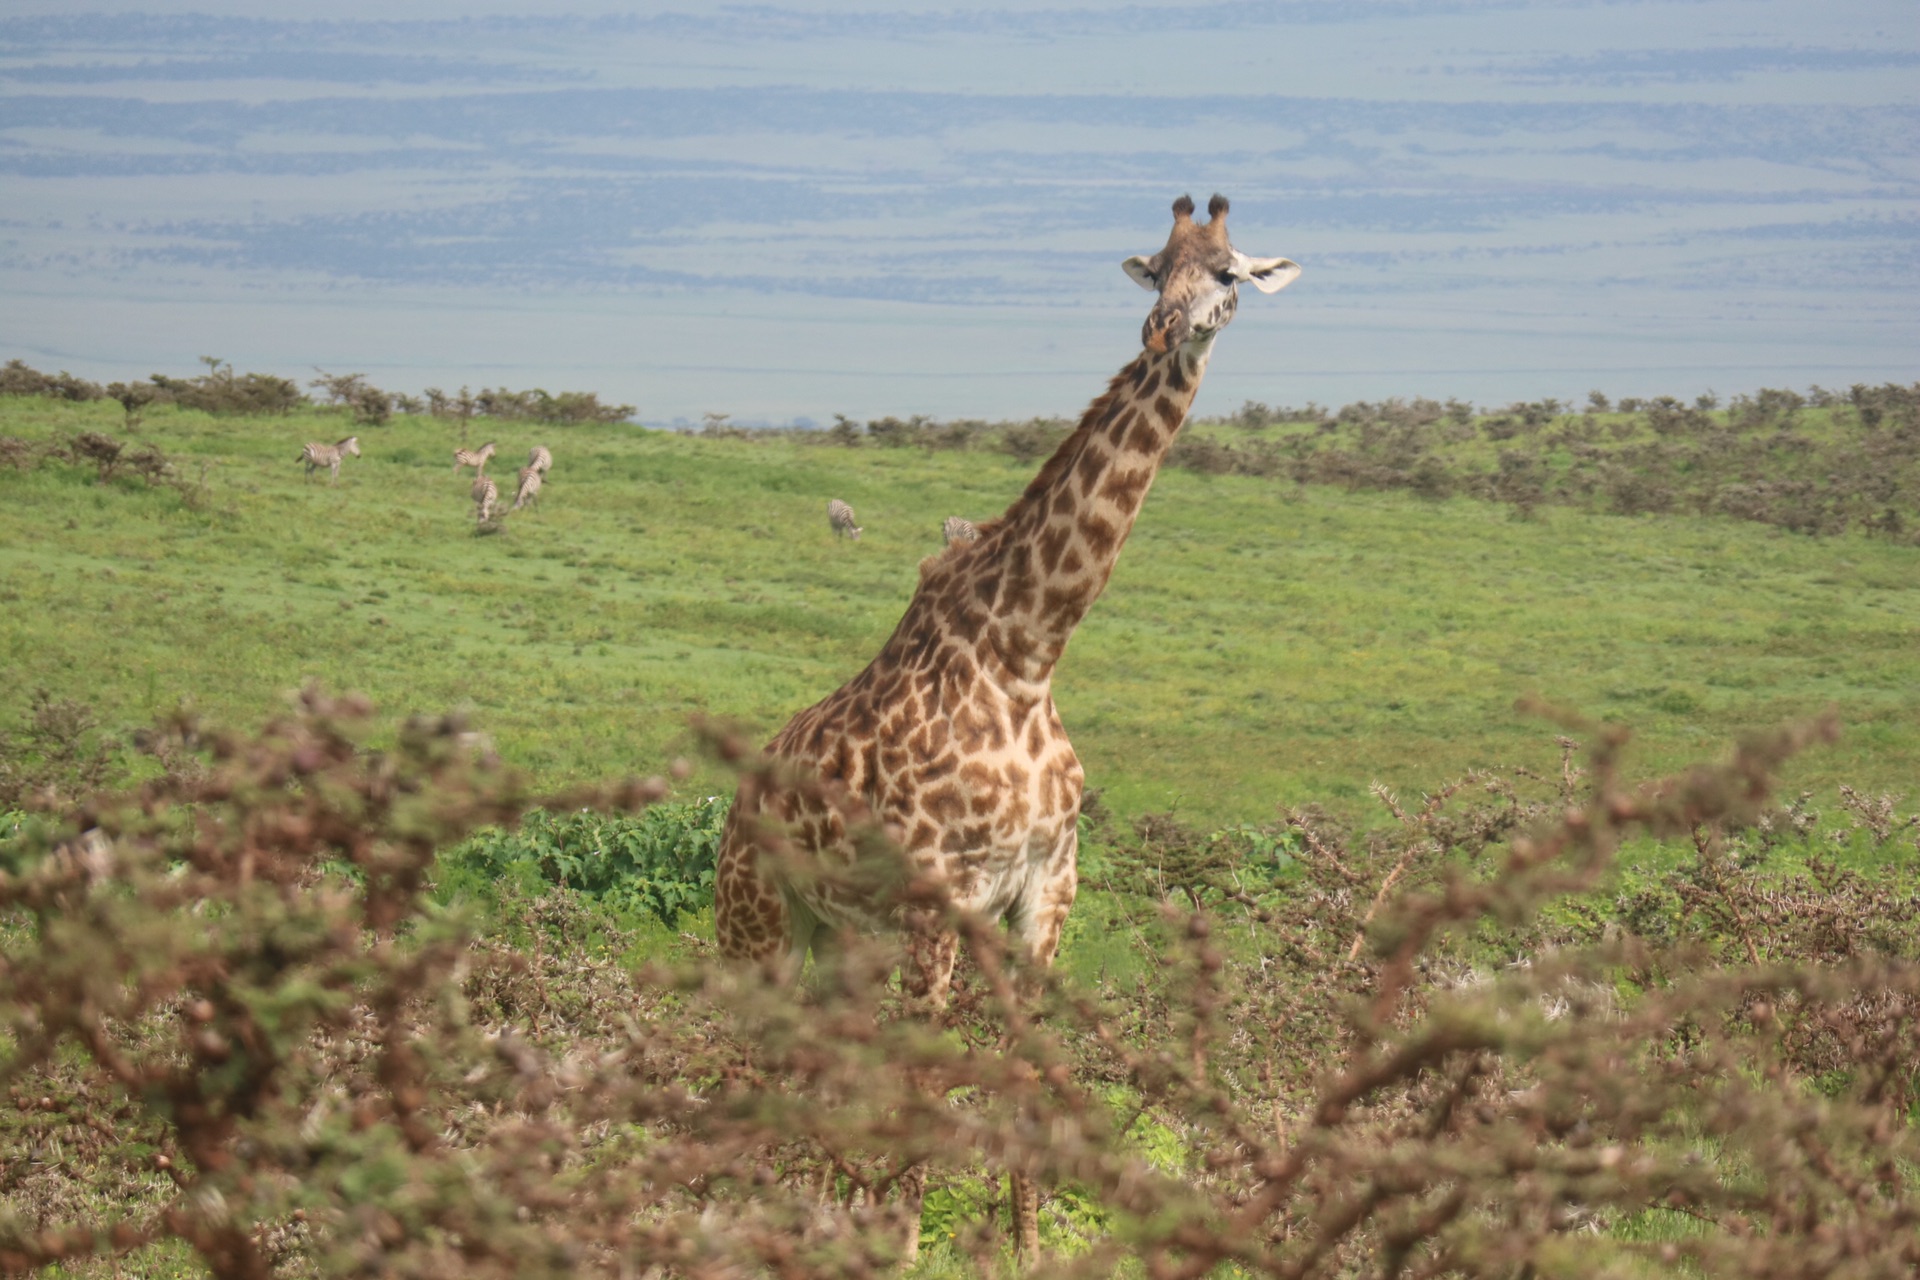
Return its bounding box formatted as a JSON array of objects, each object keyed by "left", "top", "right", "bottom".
[{"left": 1121, "top": 196, "right": 1300, "bottom": 351}]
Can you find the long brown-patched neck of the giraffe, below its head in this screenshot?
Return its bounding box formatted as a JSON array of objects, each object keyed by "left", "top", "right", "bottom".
[{"left": 968, "top": 340, "right": 1212, "bottom": 685}]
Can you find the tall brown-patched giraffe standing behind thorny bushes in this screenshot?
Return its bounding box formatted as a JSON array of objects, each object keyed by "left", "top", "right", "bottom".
[{"left": 714, "top": 196, "right": 1300, "bottom": 1259}]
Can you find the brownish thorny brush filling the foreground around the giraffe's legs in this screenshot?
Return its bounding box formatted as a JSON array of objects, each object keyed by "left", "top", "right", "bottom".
[{"left": 0, "top": 693, "right": 1920, "bottom": 1278}]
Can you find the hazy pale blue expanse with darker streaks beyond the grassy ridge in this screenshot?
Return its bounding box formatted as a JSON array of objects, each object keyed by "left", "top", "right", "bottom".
[{"left": 0, "top": 0, "right": 1920, "bottom": 422}]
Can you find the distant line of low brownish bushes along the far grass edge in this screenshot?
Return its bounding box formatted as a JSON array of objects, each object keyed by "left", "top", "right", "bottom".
[{"left": 0, "top": 357, "right": 1920, "bottom": 545}]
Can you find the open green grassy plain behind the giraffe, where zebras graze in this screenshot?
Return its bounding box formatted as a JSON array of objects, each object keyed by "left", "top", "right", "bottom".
[{"left": 0, "top": 399, "right": 1920, "bottom": 821}]
